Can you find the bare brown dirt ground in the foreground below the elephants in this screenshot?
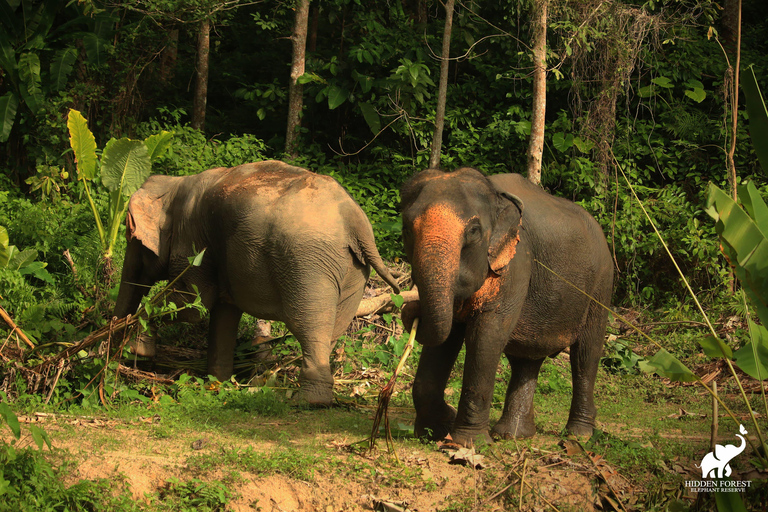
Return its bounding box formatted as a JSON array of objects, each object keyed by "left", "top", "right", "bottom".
[{"left": 7, "top": 409, "right": 695, "bottom": 512}]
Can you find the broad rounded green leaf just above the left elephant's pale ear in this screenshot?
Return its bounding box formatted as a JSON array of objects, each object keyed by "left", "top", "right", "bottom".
[{"left": 101, "top": 138, "right": 152, "bottom": 197}]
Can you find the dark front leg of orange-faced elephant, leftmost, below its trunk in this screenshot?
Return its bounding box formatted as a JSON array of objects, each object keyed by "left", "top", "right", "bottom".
[{"left": 412, "top": 326, "right": 464, "bottom": 441}]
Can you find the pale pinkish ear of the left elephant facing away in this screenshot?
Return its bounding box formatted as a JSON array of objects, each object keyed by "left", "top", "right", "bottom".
[{"left": 125, "top": 176, "right": 179, "bottom": 256}]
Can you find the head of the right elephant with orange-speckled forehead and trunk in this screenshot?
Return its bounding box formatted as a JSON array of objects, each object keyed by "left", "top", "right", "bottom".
[{"left": 401, "top": 168, "right": 523, "bottom": 346}]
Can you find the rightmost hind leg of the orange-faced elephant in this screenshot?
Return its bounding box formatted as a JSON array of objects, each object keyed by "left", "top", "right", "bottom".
[{"left": 565, "top": 303, "right": 608, "bottom": 436}]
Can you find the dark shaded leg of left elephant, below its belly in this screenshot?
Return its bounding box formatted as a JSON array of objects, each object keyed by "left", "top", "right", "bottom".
[{"left": 208, "top": 302, "right": 243, "bottom": 382}]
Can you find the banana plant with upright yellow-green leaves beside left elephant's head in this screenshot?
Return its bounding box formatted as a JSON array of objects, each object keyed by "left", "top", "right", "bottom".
[{"left": 67, "top": 110, "right": 173, "bottom": 259}]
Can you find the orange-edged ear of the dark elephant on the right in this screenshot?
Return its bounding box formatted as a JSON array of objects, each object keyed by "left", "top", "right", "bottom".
[{"left": 488, "top": 192, "right": 524, "bottom": 275}]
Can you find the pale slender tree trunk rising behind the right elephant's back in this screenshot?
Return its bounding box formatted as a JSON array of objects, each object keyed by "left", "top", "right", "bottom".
[{"left": 528, "top": 0, "right": 549, "bottom": 185}]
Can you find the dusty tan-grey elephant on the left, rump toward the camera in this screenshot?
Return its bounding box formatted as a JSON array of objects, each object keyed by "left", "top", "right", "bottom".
[{"left": 114, "top": 161, "right": 397, "bottom": 405}]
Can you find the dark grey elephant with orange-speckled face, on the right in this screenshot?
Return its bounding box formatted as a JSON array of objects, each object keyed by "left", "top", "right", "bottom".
[{"left": 401, "top": 168, "right": 613, "bottom": 446}]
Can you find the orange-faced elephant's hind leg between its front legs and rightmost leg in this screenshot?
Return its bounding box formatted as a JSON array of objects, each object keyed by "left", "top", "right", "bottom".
[{"left": 491, "top": 356, "right": 544, "bottom": 439}]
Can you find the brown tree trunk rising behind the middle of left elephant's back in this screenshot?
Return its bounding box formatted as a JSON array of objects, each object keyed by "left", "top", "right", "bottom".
[{"left": 285, "top": 0, "right": 310, "bottom": 158}]
